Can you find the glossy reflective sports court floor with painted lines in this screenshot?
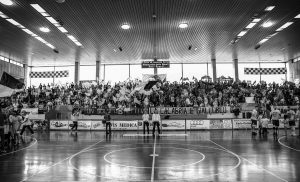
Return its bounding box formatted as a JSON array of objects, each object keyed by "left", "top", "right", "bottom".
[{"left": 0, "top": 130, "right": 300, "bottom": 182}]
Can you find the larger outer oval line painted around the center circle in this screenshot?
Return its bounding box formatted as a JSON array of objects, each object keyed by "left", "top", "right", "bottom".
[{"left": 69, "top": 143, "right": 241, "bottom": 182}]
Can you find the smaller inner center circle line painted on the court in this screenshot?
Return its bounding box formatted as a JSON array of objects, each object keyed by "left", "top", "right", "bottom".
[{"left": 102, "top": 146, "right": 205, "bottom": 169}]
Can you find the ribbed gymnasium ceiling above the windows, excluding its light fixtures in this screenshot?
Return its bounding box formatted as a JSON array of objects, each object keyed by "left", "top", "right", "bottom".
[{"left": 0, "top": 0, "right": 300, "bottom": 66}]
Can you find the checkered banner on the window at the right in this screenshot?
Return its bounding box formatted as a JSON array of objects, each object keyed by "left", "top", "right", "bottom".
[{"left": 244, "top": 68, "right": 286, "bottom": 75}]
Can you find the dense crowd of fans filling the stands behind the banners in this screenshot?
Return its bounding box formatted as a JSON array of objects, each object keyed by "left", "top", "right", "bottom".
[{"left": 0, "top": 79, "right": 300, "bottom": 115}]
